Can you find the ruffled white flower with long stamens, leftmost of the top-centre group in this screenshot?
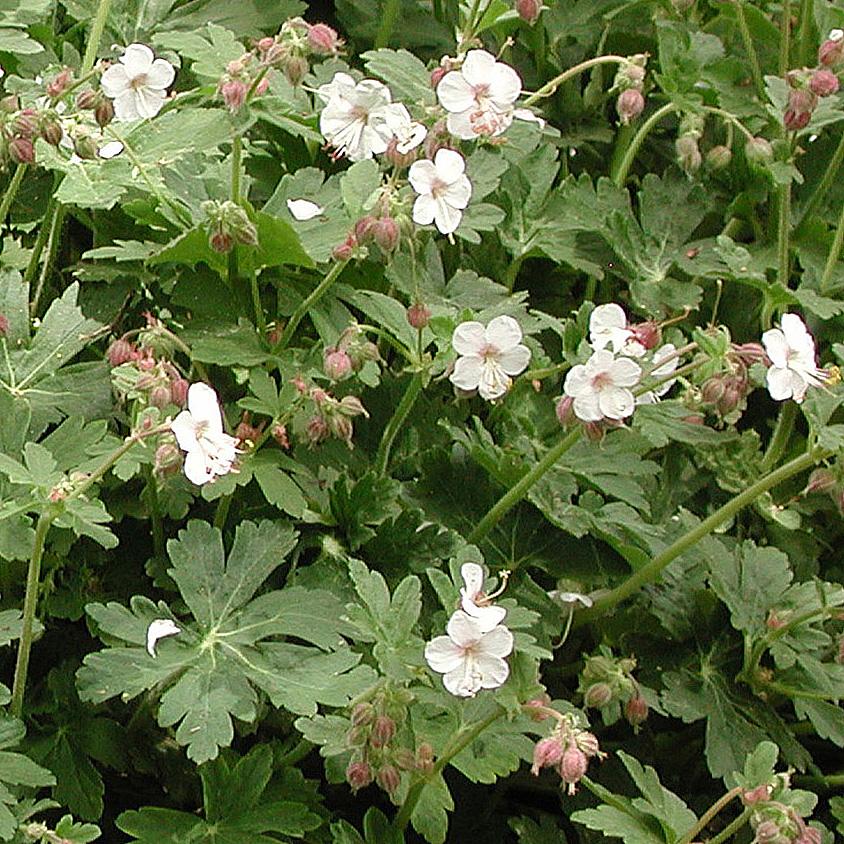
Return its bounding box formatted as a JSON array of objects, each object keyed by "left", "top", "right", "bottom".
[{"left": 317, "top": 73, "right": 393, "bottom": 161}]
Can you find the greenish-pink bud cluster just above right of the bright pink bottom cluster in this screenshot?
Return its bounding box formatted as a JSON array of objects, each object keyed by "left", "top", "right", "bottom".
[{"left": 578, "top": 648, "right": 648, "bottom": 730}]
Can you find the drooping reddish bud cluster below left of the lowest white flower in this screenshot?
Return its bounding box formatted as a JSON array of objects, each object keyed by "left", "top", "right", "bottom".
[{"left": 346, "top": 688, "right": 426, "bottom": 802}]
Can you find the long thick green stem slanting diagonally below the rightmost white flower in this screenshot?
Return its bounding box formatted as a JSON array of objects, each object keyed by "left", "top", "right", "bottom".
[{"left": 575, "top": 450, "right": 827, "bottom": 627}]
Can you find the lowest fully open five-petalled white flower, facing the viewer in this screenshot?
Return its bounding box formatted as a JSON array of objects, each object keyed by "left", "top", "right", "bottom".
[{"left": 425, "top": 610, "right": 513, "bottom": 697}]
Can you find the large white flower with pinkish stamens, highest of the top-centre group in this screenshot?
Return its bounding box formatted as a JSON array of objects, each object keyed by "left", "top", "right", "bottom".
[{"left": 437, "top": 50, "right": 522, "bottom": 140}]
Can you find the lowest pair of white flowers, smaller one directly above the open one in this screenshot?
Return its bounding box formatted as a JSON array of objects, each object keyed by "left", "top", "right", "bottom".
[{"left": 425, "top": 563, "right": 513, "bottom": 697}]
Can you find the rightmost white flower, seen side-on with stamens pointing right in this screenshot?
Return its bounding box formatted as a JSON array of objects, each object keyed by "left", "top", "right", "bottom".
[{"left": 762, "top": 314, "right": 827, "bottom": 404}]
